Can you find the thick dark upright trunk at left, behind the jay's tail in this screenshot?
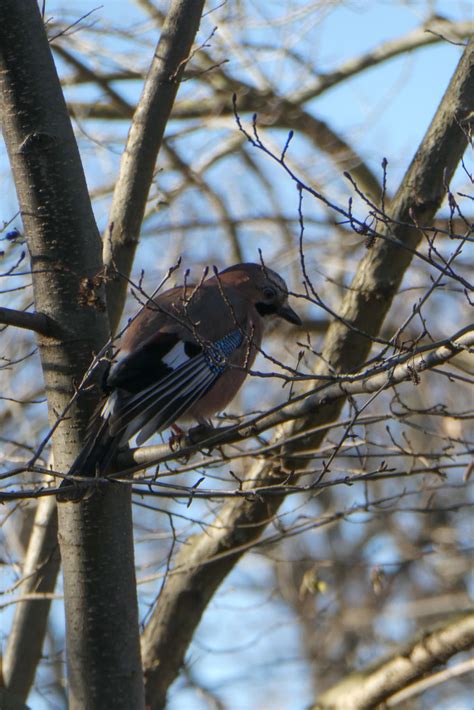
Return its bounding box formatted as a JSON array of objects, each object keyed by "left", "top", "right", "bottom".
[{"left": 0, "top": 0, "right": 143, "bottom": 709}]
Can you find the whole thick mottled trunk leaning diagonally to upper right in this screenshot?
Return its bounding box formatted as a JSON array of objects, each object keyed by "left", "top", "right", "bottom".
[{"left": 142, "top": 41, "right": 474, "bottom": 709}]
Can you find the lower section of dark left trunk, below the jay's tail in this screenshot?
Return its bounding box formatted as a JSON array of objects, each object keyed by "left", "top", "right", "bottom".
[{"left": 59, "top": 485, "right": 144, "bottom": 710}]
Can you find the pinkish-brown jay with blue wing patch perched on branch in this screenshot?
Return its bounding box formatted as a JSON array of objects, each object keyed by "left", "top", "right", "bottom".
[{"left": 70, "top": 263, "right": 301, "bottom": 476}]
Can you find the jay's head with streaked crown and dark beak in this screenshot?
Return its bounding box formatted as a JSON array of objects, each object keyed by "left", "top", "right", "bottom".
[{"left": 219, "top": 263, "right": 301, "bottom": 325}]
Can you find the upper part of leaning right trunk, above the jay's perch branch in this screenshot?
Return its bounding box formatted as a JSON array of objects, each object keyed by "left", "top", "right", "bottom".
[{"left": 323, "top": 40, "right": 474, "bottom": 378}]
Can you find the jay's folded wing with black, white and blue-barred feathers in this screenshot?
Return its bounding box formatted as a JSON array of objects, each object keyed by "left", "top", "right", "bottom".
[{"left": 102, "top": 329, "right": 243, "bottom": 445}]
